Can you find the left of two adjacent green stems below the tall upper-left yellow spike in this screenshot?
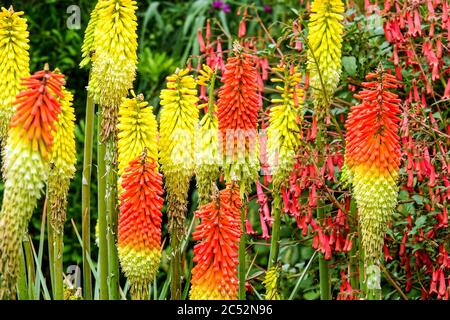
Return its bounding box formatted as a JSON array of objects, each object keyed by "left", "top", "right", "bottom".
[{"left": 97, "top": 108, "right": 109, "bottom": 300}]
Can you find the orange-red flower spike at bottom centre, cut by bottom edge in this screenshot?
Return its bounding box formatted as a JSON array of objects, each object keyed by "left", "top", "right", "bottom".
[{"left": 190, "top": 184, "right": 242, "bottom": 300}]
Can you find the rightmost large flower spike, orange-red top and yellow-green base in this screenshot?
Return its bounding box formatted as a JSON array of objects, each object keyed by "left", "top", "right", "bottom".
[{"left": 345, "top": 68, "right": 401, "bottom": 266}]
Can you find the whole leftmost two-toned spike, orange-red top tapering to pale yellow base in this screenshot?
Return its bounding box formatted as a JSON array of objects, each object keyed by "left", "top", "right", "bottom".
[{"left": 0, "top": 66, "right": 64, "bottom": 300}]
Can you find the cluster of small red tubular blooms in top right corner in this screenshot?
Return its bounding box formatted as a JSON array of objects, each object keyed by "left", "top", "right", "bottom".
[{"left": 384, "top": 0, "right": 450, "bottom": 94}]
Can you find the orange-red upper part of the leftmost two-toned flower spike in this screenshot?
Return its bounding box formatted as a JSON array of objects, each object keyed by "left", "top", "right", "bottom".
[{"left": 10, "top": 70, "right": 64, "bottom": 158}]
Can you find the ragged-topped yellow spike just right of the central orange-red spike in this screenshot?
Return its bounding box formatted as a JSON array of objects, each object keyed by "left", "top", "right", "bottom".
[{"left": 267, "top": 66, "right": 303, "bottom": 190}]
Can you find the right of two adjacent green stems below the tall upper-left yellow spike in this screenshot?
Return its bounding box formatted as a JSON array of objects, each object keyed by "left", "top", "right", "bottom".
[{"left": 106, "top": 137, "right": 119, "bottom": 300}]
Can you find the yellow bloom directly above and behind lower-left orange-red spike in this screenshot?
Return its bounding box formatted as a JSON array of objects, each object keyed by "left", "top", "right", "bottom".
[{"left": 117, "top": 92, "right": 158, "bottom": 176}]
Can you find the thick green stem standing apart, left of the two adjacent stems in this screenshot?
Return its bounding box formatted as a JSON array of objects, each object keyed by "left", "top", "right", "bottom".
[{"left": 81, "top": 94, "right": 95, "bottom": 300}]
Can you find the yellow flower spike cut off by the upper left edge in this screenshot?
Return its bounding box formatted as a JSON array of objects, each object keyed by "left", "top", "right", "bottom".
[{"left": 0, "top": 7, "right": 30, "bottom": 144}]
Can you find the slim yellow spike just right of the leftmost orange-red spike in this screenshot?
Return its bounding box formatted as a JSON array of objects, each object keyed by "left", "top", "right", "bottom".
[{"left": 48, "top": 89, "right": 77, "bottom": 233}]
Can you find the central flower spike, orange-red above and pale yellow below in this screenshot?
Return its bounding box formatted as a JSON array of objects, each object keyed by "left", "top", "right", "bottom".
[{"left": 217, "top": 48, "right": 260, "bottom": 195}]
